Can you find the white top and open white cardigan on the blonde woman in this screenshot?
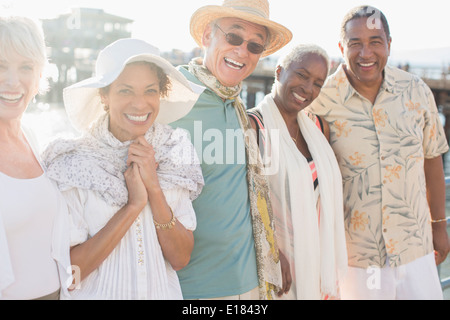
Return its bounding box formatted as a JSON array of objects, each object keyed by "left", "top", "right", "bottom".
[{"left": 0, "top": 128, "right": 70, "bottom": 300}]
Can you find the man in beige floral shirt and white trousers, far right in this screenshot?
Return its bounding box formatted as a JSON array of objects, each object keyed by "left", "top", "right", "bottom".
[{"left": 311, "top": 6, "right": 449, "bottom": 299}]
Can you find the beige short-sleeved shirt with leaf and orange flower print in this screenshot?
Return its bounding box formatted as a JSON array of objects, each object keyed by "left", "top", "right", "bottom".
[{"left": 310, "top": 65, "right": 448, "bottom": 268}]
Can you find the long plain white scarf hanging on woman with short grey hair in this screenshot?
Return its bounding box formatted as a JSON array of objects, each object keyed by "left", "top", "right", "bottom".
[{"left": 258, "top": 96, "right": 347, "bottom": 300}]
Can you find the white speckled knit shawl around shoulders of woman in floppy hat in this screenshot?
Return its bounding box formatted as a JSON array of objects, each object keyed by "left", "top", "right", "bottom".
[{"left": 43, "top": 114, "right": 204, "bottom": 207}]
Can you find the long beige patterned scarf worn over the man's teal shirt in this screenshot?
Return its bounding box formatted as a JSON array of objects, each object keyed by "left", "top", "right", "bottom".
[{"left": 189, "top": 59, "right": 281, "bottom": 300}]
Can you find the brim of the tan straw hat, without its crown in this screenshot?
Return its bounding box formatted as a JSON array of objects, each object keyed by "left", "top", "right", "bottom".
[{"left": 190, "top": 6, "right": 292, "bottom": 57}]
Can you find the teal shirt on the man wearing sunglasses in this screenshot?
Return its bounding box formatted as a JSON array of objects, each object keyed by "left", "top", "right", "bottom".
[{"left": 171, "top": 67, "right": 258, "bottom": 299}]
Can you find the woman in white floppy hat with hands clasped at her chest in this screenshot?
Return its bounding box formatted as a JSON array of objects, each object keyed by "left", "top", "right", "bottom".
[{"left": 44, "top": 39, "right": 203, "bottom": 299}]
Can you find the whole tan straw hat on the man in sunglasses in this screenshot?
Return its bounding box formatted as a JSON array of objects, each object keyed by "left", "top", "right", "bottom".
[{"left": 191, "top": 0, "right": 292, "bottom": 57}]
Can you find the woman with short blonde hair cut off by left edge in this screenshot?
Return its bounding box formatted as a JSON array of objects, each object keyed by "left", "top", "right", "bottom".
[{"left": 0, "top": 17, "right": 70, "bottom": 300}]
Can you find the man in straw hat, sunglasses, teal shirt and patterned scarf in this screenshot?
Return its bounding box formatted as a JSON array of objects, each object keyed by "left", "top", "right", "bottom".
[{"left": 171, "top": 0, "right": 292, "bottom": 300}]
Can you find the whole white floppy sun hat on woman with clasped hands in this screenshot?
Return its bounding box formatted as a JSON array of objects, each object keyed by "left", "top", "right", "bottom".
[{"left": 63, "top": 39, "right": 204, "bottom": 131}]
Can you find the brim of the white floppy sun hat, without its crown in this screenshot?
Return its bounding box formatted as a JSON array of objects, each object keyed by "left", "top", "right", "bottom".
[{"left": 63, "top": 54, "right": 205, "bottom": 132}]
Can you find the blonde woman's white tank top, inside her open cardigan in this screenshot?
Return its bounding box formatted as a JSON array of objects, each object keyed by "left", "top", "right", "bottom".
[{"left": 0, "top": 173, "right": 60, "bottom": 299}]
